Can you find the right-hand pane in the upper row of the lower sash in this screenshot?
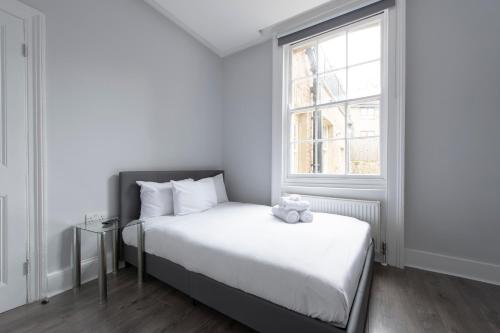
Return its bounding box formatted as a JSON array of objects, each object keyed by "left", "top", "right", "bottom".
[{"left": 347, "top": 100, "right": 380, "bottom": 138}]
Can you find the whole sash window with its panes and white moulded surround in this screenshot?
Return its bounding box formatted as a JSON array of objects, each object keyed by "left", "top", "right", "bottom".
[{"left": 269, "top": 0, "right": 406, "bottom": 266}]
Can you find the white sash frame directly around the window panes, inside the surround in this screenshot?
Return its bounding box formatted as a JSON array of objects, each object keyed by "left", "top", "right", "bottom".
[{"left": 281, "top": 11, "right": 388, "bottom": 187}]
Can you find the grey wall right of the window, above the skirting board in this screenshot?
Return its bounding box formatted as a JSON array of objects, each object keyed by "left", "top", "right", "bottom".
[{"left": 405, "top": 0, "right": 500, "bottom": 268}]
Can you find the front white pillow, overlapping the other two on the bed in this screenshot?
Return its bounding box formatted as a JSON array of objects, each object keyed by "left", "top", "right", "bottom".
[{"left": 172, "top": 178, "right": 217, "bottom": 215}]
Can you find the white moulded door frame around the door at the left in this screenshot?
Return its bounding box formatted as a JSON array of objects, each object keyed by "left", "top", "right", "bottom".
[{"left": 0, "top": 0, "right": 47, "bottom": 303}]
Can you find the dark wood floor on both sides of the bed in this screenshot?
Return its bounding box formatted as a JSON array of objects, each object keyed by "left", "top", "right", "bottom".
[{"left": 0, "top": 265, "right": 500, "bottom": 333}]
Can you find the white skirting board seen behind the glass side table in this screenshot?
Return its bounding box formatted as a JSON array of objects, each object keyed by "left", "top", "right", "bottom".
[{"left": 47, "top": 255, "right": 124, "bottom": 297}]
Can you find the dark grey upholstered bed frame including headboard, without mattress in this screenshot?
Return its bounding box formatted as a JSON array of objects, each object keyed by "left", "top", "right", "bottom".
[{"left": 120, "top": 170, "right": 375, "bottom": 333}]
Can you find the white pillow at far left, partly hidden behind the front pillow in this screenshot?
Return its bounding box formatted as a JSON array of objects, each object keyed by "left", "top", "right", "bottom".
[{"left": 136, "top": 179, "right": 193, "bottom": 219}]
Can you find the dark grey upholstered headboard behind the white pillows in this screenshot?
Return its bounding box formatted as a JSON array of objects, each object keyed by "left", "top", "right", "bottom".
[{"left": 119, "top": 170, "right": 223, "bottom": 226}]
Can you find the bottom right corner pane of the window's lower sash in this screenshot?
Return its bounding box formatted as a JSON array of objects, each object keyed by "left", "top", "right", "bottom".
[{"left": 348, "top": 138, "right": 380, "bottom": 175}]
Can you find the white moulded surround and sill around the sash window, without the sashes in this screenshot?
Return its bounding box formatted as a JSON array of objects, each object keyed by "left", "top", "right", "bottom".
[{"left": 272, "top": 0, "right": 406, "bottom": 268}]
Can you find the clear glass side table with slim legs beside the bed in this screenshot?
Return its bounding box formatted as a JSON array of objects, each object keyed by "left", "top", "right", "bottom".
[{"left": 73, "top": 218, "right": 144, "bottom": 304}]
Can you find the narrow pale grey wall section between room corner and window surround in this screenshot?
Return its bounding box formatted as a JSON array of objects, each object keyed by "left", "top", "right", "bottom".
[{"left": 222, "top": 42, "right": 272, "bottom": 204}]
